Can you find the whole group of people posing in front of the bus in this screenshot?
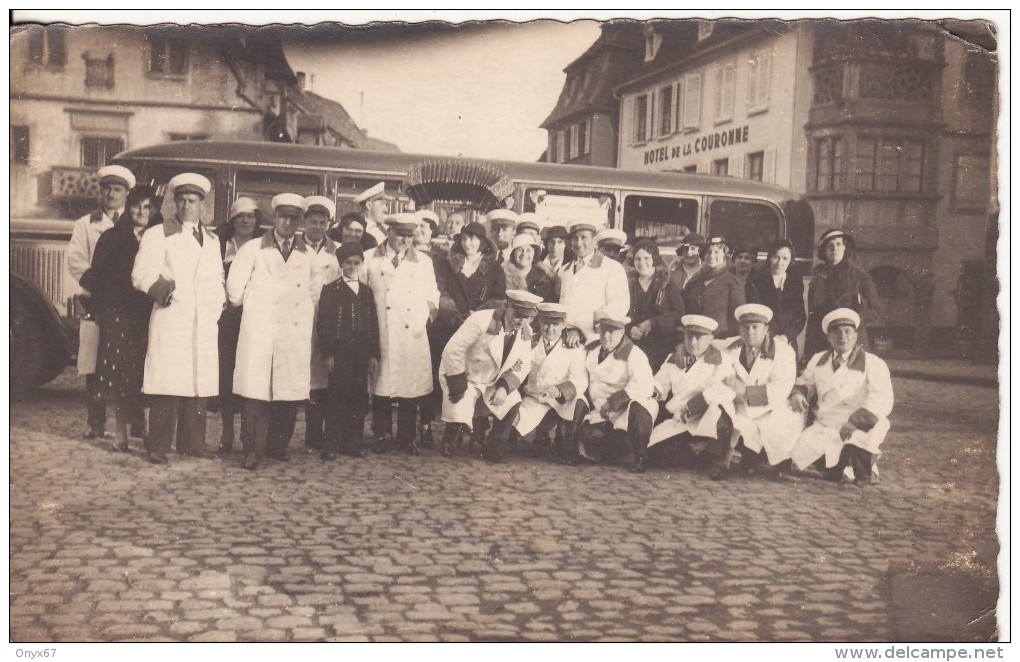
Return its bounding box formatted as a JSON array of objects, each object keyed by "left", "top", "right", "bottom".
[{"left": 67, "top": 166, "right": 893, "bottom": 483}]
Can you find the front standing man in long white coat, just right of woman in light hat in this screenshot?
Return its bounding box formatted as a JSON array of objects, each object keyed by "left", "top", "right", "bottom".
[{"left": 226, "top": 193, "right": 318, "bottom": 469}]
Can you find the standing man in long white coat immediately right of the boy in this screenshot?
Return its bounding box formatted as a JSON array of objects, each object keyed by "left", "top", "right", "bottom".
[{"left": 361, "top": 214, "right": 440, "bottom": 455}]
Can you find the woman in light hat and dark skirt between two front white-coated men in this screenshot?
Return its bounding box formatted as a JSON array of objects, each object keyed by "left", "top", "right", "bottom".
[{"left": 215, "top": 198, "right": 265, "bottom": 453}]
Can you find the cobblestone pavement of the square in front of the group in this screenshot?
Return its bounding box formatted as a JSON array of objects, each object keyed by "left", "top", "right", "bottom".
[{"left": 10, "top": 372, "right": 999, "bottom": 642}]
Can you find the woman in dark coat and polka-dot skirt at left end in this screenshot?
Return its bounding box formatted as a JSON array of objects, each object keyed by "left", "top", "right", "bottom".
[{"left": 81, "top": 187, "right": 158, "bottom": 452}]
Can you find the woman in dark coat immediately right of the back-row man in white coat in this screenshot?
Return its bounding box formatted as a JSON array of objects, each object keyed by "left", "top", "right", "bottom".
[{"left": 627, "top": 239, "right": 684, "bottom": 371}]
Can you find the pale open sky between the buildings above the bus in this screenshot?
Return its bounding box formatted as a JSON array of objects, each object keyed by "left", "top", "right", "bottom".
[{"left": 285, "top": 20, "right": 599, "bottom": 161}]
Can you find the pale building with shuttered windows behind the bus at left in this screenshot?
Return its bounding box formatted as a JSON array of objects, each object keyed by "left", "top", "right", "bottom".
[{"left": 10, "top": 24, "right": 389, "bottom": 218}]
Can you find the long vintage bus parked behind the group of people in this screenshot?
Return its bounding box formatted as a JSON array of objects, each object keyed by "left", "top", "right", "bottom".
[{"left": 3, "top": 141, "right": 814, "bottom": 386}]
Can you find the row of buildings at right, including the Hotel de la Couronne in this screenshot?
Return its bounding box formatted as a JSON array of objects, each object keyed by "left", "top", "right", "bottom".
[{"left": 550, "top": 20, "right": 997, "bottom": 350}]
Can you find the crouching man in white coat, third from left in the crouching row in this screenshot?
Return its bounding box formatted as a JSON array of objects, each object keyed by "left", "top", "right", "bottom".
[{"left": 573, "top": 308, "right": 659, "bottom": 473}]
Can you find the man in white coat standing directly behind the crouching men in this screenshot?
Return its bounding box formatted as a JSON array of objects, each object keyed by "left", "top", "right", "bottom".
[{"left": 559, "top": 220, "right": 630, "bottom": 342}]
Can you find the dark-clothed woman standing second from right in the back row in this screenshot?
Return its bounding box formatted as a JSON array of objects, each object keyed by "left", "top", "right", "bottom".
[{"left": 746, "top": 239, "right": 808, "bottom": 356}]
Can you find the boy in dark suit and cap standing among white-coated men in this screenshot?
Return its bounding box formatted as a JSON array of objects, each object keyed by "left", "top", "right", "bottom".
[{"left": 315, "top": 242, "right": 379, "bottom": 460}]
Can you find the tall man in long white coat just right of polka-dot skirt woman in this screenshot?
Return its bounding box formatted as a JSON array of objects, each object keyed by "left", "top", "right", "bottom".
[{"left": 131, "top": 172, "right": 225, "bottom": 464}]
